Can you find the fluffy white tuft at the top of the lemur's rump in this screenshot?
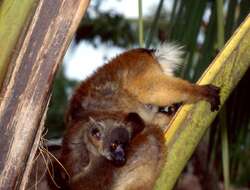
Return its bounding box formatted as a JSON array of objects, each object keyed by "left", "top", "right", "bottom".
[{"left": 154, "top": 43, "right": 184, "bottom": 76}]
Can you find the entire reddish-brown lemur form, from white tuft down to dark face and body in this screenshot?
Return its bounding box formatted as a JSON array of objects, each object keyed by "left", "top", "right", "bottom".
[{"left": 28, "top": 44, "right": 220, "bottom": 190}]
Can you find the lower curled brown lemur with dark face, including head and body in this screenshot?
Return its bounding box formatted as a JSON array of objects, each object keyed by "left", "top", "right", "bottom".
[{"left": 57, "top": 112, "right": 164, "bottom": 190}]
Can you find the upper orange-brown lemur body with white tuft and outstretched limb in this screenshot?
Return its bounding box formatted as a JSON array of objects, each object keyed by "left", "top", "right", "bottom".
[{"left": 66, "top": 43, "right": 220, "bottom": 126}]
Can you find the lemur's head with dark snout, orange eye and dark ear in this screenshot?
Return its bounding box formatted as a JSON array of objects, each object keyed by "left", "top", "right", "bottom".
[{"left": 85, "top": 113, "right": 144, "bottom": 166}]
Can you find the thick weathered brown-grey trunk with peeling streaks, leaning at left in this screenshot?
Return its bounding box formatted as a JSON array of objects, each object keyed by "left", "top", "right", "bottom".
[{"left": 0, "top": 0, "right": 89, "bottom": 190}]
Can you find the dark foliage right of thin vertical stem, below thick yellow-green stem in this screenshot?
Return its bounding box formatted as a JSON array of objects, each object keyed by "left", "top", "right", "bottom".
[{"left": 226, "top": 69, "right": 250, "bottom": 187}]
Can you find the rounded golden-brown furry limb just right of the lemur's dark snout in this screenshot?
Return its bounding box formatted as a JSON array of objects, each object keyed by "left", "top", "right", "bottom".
[{"left": 111, "top": 125, "right": 166, "bottom": 190}]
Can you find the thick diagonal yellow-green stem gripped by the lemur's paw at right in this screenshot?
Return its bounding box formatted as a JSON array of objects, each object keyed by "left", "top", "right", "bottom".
[{"left": 155, "top": 16, "right": 250, "bottom": 190}]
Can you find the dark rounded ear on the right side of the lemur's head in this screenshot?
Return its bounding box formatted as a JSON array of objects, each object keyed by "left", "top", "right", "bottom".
[{"left": 125, "top": 112, "right": 145, "bottom": 138}]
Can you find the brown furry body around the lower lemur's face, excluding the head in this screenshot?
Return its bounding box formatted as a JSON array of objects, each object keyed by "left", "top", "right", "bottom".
[{"left": 57, "top": 112, "right": 164, "bottom": 190}]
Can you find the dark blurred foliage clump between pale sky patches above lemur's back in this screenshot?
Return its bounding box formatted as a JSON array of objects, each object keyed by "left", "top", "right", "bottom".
[{"left": 75, "top": 12, "right": 136, "bottom": 47}]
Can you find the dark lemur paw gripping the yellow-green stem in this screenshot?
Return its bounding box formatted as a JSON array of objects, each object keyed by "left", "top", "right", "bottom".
[{"left": 203, "top": 84, "right": 220, "bottom": 111}]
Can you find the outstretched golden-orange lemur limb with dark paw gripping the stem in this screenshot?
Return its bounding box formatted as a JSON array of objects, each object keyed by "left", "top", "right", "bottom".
[{"left": 126, "top": 71, "right": 220, "bottom": 111}]
